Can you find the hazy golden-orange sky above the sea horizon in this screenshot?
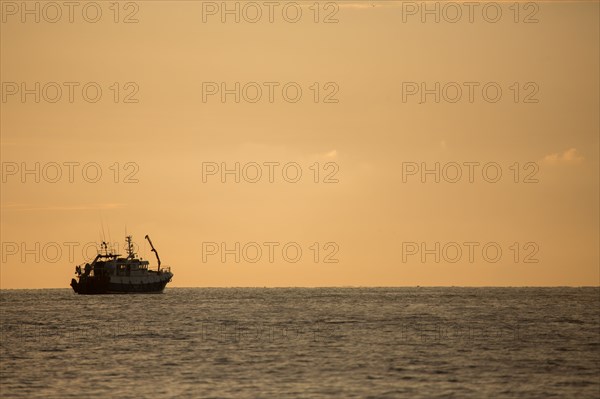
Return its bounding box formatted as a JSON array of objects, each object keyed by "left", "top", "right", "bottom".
[{"left": 0, "top": 1, "right": 600, "bottom": 289}]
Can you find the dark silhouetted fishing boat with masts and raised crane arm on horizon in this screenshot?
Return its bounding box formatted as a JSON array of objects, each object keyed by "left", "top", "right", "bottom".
[{"left": 71, "top": 235, "right": 173, "bottom": 295}]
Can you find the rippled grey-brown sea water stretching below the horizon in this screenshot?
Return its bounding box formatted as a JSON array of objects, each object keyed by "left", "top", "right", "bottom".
[{"left": 0, "top": 287, "right": 600, "bottom": 398}]
